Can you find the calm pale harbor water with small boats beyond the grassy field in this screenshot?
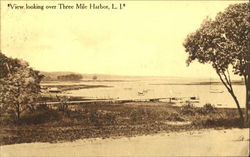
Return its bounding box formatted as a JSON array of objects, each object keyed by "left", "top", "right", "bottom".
[{"left": 53, "top": 79, "right": 245, "bottom": 108}]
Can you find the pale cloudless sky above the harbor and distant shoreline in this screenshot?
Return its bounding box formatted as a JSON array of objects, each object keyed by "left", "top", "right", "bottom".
[{"left": 1, "top": 1, "right": 246, "bottom": 77}]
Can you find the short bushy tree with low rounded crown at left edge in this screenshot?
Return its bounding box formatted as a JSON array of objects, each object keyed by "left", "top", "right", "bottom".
[{"left": 0, "top": 52, "right": 42, "bottom": 119}]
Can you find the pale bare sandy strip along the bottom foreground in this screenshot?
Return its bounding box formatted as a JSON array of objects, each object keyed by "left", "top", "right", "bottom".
[{"left": 0, "top": 129, "right": 249, "bottom": 157}]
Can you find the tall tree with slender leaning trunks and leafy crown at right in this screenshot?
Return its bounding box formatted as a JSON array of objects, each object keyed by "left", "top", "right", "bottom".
[{"left": 183, "top": 3, "right": 250, "bottom": 124}]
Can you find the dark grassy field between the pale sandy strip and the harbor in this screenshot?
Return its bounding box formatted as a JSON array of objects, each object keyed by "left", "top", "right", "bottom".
[{"left": 0, "top": 102, "right": 244, "bottom": 145}]
